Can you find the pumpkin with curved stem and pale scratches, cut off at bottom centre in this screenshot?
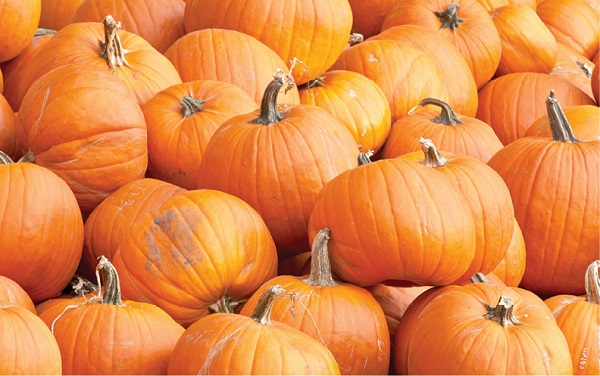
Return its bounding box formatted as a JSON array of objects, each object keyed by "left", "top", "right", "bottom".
[{"left": 168, "top": 285, "right": 340, "bottom": 375}]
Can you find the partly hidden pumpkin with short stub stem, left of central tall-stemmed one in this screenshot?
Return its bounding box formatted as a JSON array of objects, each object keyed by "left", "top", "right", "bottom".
[{"left": 142, "top": 80, "right": 258, "bottom": 189}]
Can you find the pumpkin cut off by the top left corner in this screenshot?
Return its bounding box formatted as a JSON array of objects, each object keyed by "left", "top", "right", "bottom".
[{"left": 0, "top": 0, "right": 41, "bottom": 63}]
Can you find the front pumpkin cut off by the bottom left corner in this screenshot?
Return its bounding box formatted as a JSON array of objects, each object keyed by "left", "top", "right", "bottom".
[{"left": 0, "top": 303, "right": 62, "bottom": 375}]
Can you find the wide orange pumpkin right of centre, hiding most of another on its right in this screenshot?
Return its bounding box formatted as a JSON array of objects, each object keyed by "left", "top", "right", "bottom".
[{"left": 309, "top": 152, "right": 475, "bottom": 286}]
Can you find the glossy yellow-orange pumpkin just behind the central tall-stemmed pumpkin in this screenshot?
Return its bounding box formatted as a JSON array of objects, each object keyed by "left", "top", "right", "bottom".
[{"left": 299, "top": 70, "right": 392, "bottom": 152}]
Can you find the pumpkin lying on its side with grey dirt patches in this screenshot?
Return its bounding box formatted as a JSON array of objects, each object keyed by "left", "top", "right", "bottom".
[{"left": 113, "top": 189, "right": 277, "bottom": 326}]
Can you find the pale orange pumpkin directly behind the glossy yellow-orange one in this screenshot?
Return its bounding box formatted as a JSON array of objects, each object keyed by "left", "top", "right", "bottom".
[{"left": 333, "top": 40, "right": 449, "bottom": 123}]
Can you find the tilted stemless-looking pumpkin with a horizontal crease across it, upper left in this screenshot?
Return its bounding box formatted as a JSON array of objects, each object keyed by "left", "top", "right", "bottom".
[{"left": 17, "top": 64, "right": 148, "bottom": 214}]
